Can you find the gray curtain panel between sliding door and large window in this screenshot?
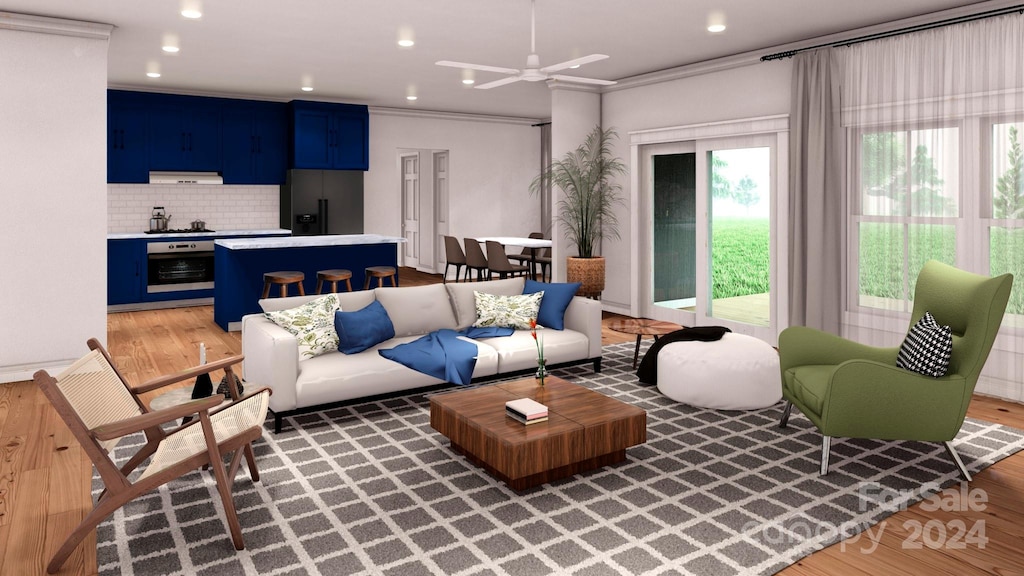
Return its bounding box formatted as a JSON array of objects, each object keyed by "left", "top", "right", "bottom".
[{"left": 788, "top": 48, "right": 846, "bottom": 334}]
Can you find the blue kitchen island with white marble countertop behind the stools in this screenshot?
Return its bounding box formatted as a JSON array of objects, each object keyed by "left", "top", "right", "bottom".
[{"left": 213, "top": 234, "right": 406, "bottom": 331}]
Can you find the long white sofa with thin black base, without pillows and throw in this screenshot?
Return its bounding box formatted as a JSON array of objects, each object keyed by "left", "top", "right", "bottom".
[{"left": 242, "top": 278, "right": 601, "bottom": 431}]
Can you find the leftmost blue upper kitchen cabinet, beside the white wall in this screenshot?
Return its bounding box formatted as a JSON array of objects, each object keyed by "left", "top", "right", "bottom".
[{"left": 106, "top": 90, "right": 150, "bottom": 183}]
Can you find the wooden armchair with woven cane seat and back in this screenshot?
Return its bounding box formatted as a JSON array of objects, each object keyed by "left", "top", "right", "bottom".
[{"left": 33, "top": 338, "right": 270, "bottom": 574}]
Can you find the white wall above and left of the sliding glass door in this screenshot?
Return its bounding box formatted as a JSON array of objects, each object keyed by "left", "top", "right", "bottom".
[{"left": 601, "top": 59, "right": 793, "bottom": 314}]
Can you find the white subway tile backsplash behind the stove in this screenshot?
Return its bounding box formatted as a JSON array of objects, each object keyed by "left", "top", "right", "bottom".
[{"left": 106, "top": 184, "right": 281, "bottom": 234}]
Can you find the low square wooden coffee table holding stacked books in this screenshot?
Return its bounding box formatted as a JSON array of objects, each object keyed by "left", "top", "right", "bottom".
[{"left": 430, "top": 376, "right": 647, "bottom": 490}]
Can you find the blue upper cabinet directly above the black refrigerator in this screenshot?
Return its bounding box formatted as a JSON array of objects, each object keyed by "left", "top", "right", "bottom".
[{"left": 290, "top": 100, "right": 370, "bottom": 170}]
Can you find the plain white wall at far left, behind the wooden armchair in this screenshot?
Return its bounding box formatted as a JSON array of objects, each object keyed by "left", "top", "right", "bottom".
[{"left": 0, "top": 21, "right": 110, "bottom": 381}]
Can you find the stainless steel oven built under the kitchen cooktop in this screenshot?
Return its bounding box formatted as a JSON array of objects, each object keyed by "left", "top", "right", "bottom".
[{"left": 145, "top": 240, "right": 213, "bottom": 294}]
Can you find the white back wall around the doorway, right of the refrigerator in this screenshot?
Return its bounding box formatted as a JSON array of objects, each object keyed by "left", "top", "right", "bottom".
[{"left": 364, "top": 109, "right": 541, "bottom": 260}]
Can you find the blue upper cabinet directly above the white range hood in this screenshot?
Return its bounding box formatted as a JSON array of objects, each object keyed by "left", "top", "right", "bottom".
[{"left": 150, "top": 94, "right": 221, "bottom": 172}]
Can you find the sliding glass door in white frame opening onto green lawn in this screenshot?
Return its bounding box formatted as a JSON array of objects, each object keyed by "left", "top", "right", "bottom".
[{"left": 641, "top": 136, "right": 777, "bottom": 342}]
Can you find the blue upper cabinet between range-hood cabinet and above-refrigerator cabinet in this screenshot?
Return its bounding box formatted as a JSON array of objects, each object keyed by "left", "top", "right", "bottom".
[{"left": 221, "top": 100, "right": 288, "bottom": 184}]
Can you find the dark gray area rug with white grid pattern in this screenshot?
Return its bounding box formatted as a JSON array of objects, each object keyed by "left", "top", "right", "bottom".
[{"left": 93, "top": 342, "right": 1024, "bottom": 576}]
